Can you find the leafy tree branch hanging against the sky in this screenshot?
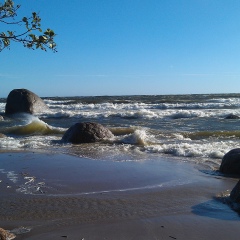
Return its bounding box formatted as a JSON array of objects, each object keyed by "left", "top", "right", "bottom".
[{"left": 0, "top": 0, "right": 57, "bottom": 52}]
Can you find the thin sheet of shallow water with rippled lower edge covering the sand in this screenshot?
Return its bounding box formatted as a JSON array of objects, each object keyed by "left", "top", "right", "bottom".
[{"left": 0, "top": 152, "right": 237, "bottom": 220}]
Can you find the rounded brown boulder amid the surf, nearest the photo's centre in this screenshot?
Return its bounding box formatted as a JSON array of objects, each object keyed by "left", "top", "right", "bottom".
[{"left": 62, "top": 122, "right": 113, "bottom": 143}]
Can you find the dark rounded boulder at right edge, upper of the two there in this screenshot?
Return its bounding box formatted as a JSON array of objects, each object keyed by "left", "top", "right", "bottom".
[{"left": 219, "top": 148, "right": 240, "bottom": 174}]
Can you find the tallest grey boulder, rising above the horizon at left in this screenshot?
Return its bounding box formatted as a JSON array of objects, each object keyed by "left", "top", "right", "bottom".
[{"left": 5, "top": 89, "right": 48, "bottom": 114}]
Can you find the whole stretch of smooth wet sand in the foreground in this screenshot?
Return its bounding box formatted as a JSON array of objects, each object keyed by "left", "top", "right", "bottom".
[{"left": 0, "top": 152, "right": 240, "bottom": 240}]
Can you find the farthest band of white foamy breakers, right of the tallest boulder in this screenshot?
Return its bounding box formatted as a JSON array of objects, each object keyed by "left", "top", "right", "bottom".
[{"left": 40, "top": 100, "right": 240, "bottom": 119}]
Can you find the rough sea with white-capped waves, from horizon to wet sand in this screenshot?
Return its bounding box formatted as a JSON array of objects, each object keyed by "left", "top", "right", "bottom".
[{"left": 0, "top": 94, "right": 240, "bottom": 169}]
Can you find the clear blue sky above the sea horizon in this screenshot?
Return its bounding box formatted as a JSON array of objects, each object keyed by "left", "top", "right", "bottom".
[{"left": 0, "top": 0, "right": 240, "bottom": 97}]
